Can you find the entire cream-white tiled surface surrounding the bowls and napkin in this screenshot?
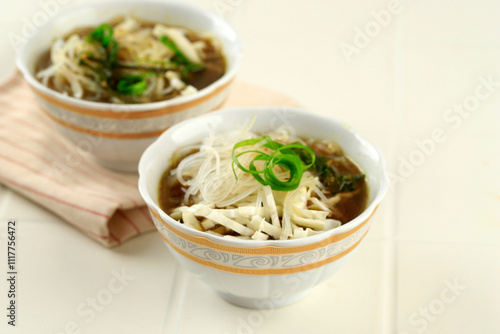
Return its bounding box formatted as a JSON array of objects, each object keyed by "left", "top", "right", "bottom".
[{"left": 0, "top": 0, "right": 500, "bottom": 334}]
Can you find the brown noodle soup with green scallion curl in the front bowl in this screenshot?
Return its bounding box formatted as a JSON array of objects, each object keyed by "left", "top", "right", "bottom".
[{"left": 158, "top": 122, "right": 368, "bottom": 240}]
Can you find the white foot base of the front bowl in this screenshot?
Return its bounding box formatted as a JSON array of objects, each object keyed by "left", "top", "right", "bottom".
[{"left": 217, "top": 290, "right": 310, "bottom": 309}]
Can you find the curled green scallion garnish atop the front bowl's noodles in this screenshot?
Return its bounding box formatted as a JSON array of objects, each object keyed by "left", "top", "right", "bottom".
[{"left": 232, "top": 136, "right": 315, "bottom": 191}]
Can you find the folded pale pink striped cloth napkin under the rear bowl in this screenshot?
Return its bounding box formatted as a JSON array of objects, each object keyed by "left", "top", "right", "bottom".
[{"left": 0, "top": 74, "right": 297, "bottom": 247}]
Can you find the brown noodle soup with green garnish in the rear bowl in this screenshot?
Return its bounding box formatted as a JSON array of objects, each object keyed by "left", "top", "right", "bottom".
[{"left": 36, "top": 17, "right": 226, "bottom": 103}]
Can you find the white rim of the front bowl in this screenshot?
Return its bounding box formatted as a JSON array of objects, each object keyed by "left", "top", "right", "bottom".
[{"left": 138, "top": 106, "right": 389, "bottom": 248}]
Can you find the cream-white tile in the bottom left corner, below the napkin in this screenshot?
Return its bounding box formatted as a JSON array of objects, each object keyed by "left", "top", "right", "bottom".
[{"left": 1, "top": 219, "right": 175, "bottom": 333}]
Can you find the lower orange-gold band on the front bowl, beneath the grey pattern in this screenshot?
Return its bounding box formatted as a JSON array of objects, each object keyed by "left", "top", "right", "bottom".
[{"left": 160, "top": 226, "right": 368, "bottom": 276}]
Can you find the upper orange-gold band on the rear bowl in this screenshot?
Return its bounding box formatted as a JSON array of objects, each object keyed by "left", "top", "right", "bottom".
[{"left": 31, "top": 77, "right": 234, "bottom": 120}]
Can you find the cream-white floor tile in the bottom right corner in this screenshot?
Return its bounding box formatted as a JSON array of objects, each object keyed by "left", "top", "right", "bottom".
[{"left": 398, "top": 242, "right": 500, "bottom": 333}]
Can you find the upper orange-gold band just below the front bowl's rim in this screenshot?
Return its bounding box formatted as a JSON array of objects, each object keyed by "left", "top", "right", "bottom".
[{"left": 149, "top": 206, "right": 378, "bottom": 255}]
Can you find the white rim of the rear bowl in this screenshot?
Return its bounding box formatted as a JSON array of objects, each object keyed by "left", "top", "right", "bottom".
[{"left": 16, "top": 0, "right": 242, "bottom": 113}]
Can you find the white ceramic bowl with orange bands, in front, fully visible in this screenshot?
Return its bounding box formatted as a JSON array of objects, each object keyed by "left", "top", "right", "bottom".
[{"left": 139, "top": 107, "right": 389, "bottom": 308}]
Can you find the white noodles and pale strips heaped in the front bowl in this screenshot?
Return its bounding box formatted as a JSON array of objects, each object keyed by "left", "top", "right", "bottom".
[{"left": 172, "top": 124, "right": 340, "bottom": 240}]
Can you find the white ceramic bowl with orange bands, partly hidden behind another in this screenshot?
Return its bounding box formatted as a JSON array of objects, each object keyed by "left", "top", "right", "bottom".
[{"left": 17, "top": 1, "right": 241, "bottom": 171}]
